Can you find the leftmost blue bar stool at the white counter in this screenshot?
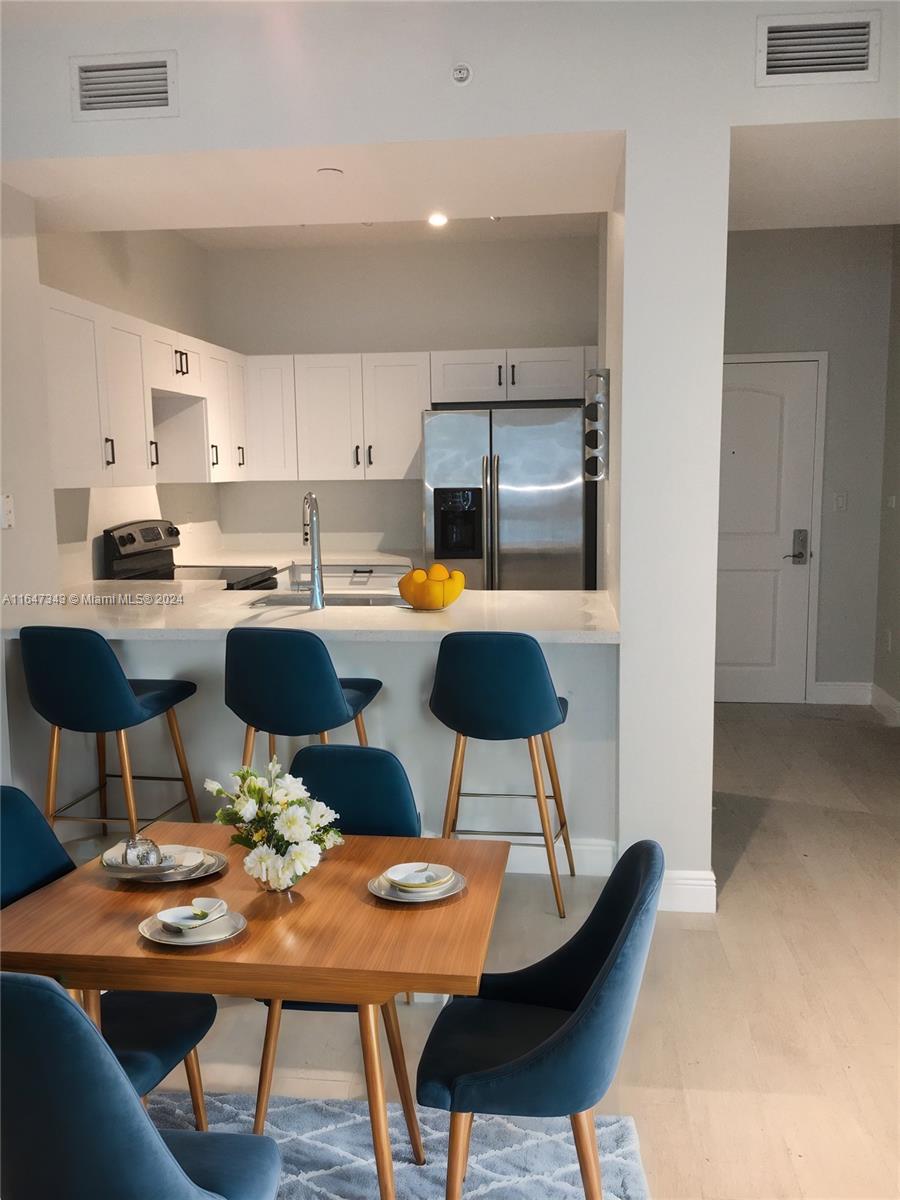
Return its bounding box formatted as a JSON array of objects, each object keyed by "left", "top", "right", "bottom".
[{"left": 19, "top": 625, "right": 199, "bottom": 833}]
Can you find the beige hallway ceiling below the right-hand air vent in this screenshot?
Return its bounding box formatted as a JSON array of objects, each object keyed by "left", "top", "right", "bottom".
[{"left": 728, "top": 120, "right": 900, "bottom": 229}]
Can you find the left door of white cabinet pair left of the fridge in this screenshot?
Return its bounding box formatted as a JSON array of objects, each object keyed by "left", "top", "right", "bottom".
[{"left": 294, "top": 354, "right": 365, "bottom": 480}]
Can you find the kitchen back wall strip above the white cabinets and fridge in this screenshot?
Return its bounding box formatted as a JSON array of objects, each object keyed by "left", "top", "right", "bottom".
[{"left": 209, "top": 235, "right": 598, "bottom": 354}]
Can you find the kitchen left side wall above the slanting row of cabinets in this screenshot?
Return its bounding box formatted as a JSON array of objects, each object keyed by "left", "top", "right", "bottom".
[{"left": 37, "top": 232, "right": 210, "bottom": 340}]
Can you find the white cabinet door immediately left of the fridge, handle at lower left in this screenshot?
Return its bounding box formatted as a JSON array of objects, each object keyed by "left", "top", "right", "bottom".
[{"left": 362, "top": 352, "right": 431, "bottom": 479}]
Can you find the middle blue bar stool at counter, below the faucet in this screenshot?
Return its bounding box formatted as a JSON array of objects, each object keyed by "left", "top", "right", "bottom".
[{"left": 226, "top": 629, "right": 382, "bottom": 767}]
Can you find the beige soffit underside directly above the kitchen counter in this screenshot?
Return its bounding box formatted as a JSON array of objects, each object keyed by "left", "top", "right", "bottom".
[{"left": 4, "top": 133, "right": 624, "bottom": 230}]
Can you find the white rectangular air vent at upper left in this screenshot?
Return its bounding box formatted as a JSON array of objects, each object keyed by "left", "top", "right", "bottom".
[{"left": 70, "top": 50, "right": 178, "bottom": 121}]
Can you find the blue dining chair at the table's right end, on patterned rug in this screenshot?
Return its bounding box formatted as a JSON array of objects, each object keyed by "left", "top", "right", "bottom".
[{"left": 418, "top": 841, "right": 664, "bottom": 1200}]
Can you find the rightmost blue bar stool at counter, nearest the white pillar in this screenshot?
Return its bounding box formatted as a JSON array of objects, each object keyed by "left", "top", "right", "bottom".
[{"left": 430, "top": 634, "right": 575, "bottom": 917}]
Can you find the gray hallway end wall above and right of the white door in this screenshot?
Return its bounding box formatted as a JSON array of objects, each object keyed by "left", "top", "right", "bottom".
[{"left": 725, "top": 227, "right": 892, "bottom": 683}]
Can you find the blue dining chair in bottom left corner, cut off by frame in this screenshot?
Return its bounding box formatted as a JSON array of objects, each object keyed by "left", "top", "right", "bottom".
[{"left": 0, "top": 973, "right": 281, "bottom": 1200}]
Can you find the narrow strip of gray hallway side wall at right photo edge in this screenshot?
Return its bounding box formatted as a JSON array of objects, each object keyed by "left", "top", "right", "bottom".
[{"left": 875, "top": 226, "right": 900, "bottom": 701}]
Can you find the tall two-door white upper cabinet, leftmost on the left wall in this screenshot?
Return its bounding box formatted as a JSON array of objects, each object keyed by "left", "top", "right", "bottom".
[{"left": 43, "top": 288, "right": 155, "bottom": 487}]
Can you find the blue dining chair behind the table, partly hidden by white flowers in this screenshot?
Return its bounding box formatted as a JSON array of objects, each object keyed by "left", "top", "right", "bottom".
[{"left": 253, "top": 745, "right": 425, "bottom": 1164}]
